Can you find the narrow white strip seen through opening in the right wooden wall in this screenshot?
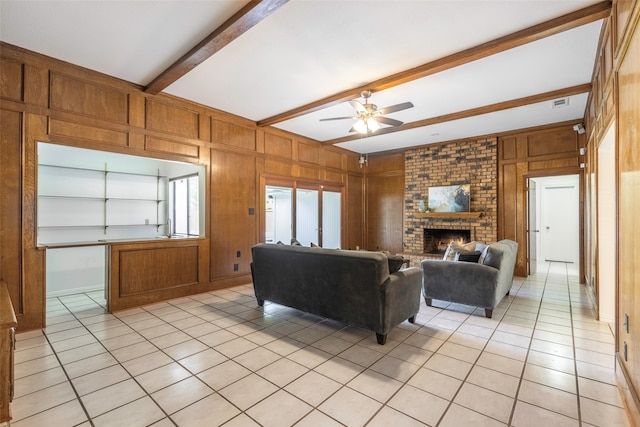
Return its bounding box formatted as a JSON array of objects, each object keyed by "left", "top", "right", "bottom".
[{"left": 597, "top": 124, "right": 616, "bottom": 323}]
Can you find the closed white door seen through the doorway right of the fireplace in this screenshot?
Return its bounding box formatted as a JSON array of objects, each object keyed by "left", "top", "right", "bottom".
[{"left": 541, "top": 175, "right": 580, "bottom": 264}]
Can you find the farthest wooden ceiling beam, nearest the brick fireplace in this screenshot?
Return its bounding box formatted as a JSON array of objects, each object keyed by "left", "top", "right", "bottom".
[{"left": 321, "top": 83, "right": 591, "bottom": 145}]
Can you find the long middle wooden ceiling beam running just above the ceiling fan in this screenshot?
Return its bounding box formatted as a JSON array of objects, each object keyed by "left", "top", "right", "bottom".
[{"left": 258, "top": 1, "right": 611, "bottom": 126}]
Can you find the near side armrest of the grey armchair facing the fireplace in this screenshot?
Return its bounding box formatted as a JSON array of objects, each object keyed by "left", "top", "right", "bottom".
[{"left": 421, "top": 260, "right": 502, "bottom": 308}]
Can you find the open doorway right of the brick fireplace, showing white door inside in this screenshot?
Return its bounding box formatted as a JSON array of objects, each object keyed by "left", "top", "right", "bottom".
[{"left": 527, "top": 175, "right": 580, "bottom": 274}]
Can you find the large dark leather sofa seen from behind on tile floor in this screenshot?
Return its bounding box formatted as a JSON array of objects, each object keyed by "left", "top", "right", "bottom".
[{"left": 251, "top": 243, "right": 422, "bottom": 344}]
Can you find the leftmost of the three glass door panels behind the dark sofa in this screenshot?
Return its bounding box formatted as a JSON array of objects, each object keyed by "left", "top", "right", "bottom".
[{"left": 264, "top": 185, "right": 293, "bottom": 245}]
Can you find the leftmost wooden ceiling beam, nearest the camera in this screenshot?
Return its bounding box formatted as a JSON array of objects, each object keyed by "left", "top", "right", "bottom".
[{"left": 144, "top": 0, "right": 289, "bottom": 95}]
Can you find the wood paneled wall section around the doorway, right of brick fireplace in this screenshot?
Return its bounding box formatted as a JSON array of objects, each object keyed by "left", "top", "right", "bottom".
[{"left": 498, "top": 124, "right": 584, "bottom": 277}]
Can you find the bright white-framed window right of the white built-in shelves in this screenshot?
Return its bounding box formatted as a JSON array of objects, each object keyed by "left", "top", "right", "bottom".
[{"left": 169, "top": 175, "right": 200, "bottom": 237}]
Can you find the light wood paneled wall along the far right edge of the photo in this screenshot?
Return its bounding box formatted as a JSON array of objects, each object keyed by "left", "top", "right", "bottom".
[{"left": 604, "top": 0, "right": 640, "bottom": 425}]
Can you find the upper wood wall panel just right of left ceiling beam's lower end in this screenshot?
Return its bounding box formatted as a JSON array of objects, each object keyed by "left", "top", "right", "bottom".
[{"left": 146, "top": 99, "right": 200, "bottom": 138}]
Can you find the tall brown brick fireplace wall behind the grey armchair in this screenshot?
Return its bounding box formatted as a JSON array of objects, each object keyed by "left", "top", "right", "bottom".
[{"left": 404, "top": 138, "right": 498, "bottom": 266}]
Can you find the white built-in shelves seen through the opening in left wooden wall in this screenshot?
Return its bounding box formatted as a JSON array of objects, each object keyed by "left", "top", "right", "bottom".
[{"left": 38, "top": 163, "right": 169, "bottom": 243}]
